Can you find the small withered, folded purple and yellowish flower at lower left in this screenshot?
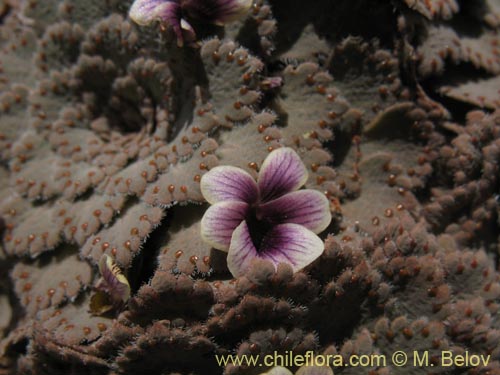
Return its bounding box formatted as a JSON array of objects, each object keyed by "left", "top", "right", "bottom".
[{"left": 90, "top": 254, "right": 130, "bottom": 315}]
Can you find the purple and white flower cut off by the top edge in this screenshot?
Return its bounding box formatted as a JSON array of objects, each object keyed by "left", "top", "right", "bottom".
[{"left": 129, "top": 0, "right": 253, "bottom": 46}]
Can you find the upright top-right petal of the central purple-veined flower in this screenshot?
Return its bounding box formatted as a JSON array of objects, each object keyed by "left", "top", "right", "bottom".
[{"left": 258, "top": 147, "right": 308, "bottom": 202}]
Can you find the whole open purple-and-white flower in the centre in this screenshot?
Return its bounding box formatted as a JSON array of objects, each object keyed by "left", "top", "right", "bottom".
[{"left": 201, "top": 148, "right": 332, "bottom": 277}]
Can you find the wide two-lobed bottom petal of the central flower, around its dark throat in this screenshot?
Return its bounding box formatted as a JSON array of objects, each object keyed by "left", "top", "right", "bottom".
[{"left": 227, "top": 222, "right": 324, "bottom": 277}]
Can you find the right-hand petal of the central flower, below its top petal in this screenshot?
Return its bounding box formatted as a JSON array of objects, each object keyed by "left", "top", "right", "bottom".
[{"left": 257, "top": 189, "right": 332, "bottom": 233}]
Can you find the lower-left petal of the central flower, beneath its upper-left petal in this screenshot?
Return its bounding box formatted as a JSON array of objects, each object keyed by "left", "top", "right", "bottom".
[{"left": 201, "top": 201, "right": 249, "bottom": 251}]
